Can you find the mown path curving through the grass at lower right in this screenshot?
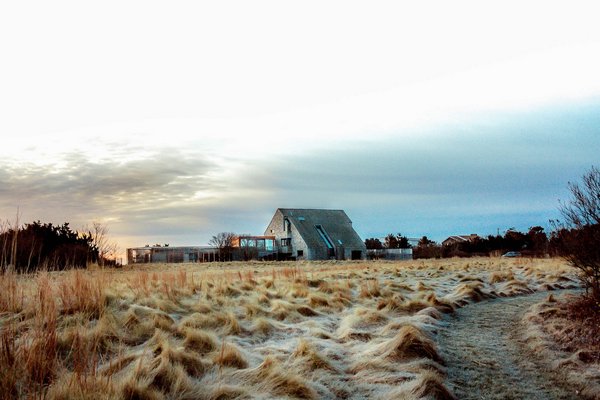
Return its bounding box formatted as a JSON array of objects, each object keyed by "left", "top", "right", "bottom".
[{"left": 438, "top": 290, "right": 577, "bottom": 400}]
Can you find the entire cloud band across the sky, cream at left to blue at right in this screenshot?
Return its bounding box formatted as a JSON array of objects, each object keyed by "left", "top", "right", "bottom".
[{"left": 0, "top": 101, "right": 600, "bottom": 252}]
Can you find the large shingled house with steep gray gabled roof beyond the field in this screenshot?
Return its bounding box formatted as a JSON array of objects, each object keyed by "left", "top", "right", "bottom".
[{"left": 265, "top": 208, "right": 367, "bottom": 260}]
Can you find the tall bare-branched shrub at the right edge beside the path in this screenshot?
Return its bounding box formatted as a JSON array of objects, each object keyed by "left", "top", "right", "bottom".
[{"left": 553, "top": 167, "right": 600, "bottom": 302}]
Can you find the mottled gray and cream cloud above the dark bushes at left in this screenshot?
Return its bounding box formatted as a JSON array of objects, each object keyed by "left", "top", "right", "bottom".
[{"left": 0, "top": 148, "right": 222, "bottom": 238}]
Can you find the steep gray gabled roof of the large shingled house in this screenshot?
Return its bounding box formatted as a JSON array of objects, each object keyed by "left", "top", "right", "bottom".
[{"left": 277, "top": 208, "right": 365, "bottom": 249}]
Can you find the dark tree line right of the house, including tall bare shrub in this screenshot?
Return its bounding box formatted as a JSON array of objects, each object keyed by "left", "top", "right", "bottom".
[{"left": 365, "top": 166, "right": 600, "bottom": 304}]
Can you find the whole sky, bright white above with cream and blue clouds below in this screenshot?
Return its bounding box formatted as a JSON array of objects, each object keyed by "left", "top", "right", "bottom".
[{"left": 0, "top": 0, "right": 600, "bottom": 260}]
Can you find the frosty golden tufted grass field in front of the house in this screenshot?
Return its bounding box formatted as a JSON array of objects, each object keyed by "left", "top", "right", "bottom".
[{"left": 0, "top": 258, "right": 577, "bottom": 399}]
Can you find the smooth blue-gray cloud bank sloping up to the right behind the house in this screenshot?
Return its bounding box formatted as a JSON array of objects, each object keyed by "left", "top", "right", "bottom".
[{"left": 240, "top": 102, "right": 600, "bottom": 236}]
